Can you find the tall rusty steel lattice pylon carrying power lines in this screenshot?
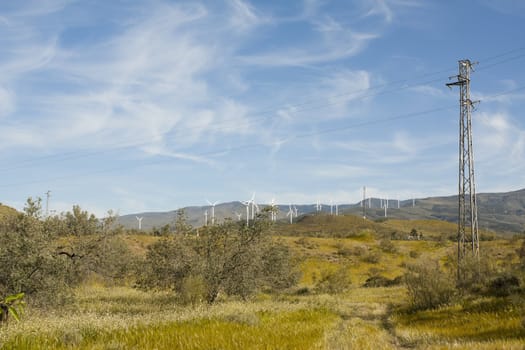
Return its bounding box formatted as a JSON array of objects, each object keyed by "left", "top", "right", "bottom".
[{"left": 447, "top": 60, "right": 479, "bottom": 281}]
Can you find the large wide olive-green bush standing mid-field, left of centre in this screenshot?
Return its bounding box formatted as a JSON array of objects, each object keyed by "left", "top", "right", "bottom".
[{"left": 137, "top": 220, "right": 299, "bottom": 303}]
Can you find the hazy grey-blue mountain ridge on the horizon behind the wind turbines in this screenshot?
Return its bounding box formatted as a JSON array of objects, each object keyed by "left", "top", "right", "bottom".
[{"left": 119, "top": 189, "right": 525, "bottom": 233}]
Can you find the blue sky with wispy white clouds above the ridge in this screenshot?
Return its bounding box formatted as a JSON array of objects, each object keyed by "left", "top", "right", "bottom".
[{"left": 0, "top": 0, "right": 525, "bottom": 217}]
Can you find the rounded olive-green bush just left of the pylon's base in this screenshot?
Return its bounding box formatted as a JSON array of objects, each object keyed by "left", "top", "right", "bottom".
[{"left": 405, "top": 261, "right": 456, "bottom": 309}]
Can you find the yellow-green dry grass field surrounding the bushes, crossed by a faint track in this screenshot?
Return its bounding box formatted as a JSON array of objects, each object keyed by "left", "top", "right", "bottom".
[{"left": 0, "top": 217, "right": 525, "bottom": 349}]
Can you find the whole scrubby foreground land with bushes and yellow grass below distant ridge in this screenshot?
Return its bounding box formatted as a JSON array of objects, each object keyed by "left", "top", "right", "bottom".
[{"left": 0, "top": 199, "right": 525, "bottom": 349}]
